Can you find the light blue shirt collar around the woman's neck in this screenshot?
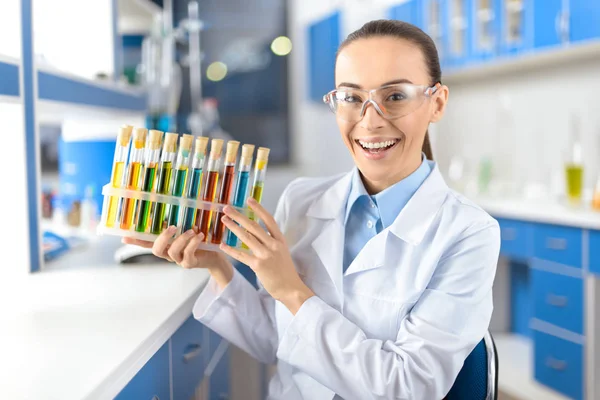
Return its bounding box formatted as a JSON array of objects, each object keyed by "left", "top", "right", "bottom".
[{"left": 345, "top": 156, "right": 434, "bottom": 229}]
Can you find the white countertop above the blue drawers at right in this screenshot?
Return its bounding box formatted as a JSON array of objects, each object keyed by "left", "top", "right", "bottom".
[{"left": 471, "top": 197, "right": 600, "bottom": 230}]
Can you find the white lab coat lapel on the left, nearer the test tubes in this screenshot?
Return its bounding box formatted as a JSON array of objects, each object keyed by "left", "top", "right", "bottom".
[{"left": 307, "top": 172, "right": 352, "bottom": 303}]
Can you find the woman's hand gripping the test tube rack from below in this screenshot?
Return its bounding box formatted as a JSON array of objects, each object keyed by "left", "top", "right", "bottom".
[{"left": 123, "top": 226, "right": 233, "bottom": 289}]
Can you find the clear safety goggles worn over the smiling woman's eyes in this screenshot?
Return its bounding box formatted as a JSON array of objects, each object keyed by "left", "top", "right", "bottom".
[{"left": 323, "top": 83, "right": 440, "bottom": 122}]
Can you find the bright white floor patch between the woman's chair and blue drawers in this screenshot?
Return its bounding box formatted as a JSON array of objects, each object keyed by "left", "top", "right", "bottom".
[{"left": 494, "top": 333, "right": 568, "bottom": 400}]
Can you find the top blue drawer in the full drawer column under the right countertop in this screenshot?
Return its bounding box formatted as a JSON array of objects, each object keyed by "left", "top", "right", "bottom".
[{"left": 533, "top": 225, "right": 583, "bottom": 268}]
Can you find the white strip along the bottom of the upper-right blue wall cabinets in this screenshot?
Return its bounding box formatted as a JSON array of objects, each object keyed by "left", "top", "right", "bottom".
[{"left": 442, "top": 41, "right": 600, "bottom": 84}]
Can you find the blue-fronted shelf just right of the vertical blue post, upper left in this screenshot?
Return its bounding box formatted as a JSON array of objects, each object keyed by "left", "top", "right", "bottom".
[{"left": 38, "top": 64, "right": 146, "bottom": 113}]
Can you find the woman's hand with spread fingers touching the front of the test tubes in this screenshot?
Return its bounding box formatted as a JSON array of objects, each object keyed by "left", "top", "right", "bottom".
[{"left": 221, "top": 198, "right": 314, "bottom": 314}]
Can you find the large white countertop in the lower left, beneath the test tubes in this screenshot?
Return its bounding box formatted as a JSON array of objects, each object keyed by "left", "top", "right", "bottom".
[{"left": 0, "top": 264, "right": 208, "bottom": 400}]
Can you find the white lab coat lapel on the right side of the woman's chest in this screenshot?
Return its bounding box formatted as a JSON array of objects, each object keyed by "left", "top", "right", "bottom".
[{"left": 346, "top": 165, "right": 448, "bottom": 275}]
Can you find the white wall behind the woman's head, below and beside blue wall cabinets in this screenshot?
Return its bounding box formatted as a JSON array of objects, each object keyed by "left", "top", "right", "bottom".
[{"left": 289, "top": 0, "right": 600, "bottom": 200}]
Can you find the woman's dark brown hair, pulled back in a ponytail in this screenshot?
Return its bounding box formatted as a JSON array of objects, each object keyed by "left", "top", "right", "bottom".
[{"left": 336, "top": 19, "right": 442, "bottom": 160}]
